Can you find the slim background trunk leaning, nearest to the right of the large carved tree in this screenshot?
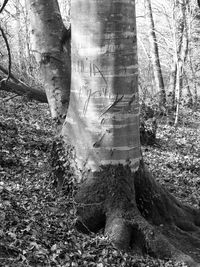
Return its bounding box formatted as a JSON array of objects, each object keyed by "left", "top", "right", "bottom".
[{"left": 145, "top": 0, "right": 166, "bottom": 105}]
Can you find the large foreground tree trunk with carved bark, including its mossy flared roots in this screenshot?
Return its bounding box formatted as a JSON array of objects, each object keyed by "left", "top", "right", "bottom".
[{"left": 28, "top": 0, "right": 200, "bottom": 267}]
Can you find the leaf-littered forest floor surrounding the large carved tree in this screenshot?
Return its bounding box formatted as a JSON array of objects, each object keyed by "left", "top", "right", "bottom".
[{"left": 0, "top": 92, "right": 200, "bottom": 267}]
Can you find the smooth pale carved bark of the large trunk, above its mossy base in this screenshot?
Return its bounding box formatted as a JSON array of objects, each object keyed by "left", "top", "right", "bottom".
[{"left": 64, "top": 0, "right": 141, "bottom": 176}]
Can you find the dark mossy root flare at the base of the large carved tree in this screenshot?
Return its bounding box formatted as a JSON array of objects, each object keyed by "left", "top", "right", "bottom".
[{"left": 77, "top": 163, "right": 200, "bottom": 267}]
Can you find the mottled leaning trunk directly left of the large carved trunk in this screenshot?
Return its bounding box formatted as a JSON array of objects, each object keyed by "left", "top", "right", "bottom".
[{"left": 28, "top": 0, "right": 70, "bottom": 125}]
